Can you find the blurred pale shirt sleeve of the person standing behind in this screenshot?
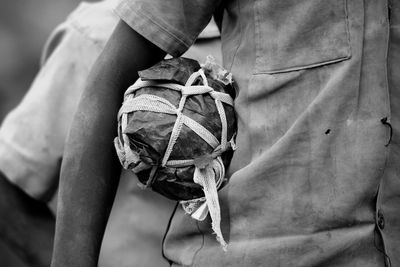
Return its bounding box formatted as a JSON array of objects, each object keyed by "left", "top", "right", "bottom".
[{"left": 0, "top": 27, "right": 101, "bottom": 201}]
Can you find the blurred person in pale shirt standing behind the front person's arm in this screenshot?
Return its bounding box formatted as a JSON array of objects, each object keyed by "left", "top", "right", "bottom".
[{"left": 0, "top": 0, "right": 221, "bottom": 267}]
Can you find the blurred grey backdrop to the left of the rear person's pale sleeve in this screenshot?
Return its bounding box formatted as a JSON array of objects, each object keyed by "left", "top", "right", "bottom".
[{"left": 0, "top": 0, "right": 93, "bottom": 267}]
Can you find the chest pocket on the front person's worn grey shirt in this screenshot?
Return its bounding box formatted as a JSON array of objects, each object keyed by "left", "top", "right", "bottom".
[{"left": 255, "top": 0, "right": 351, "bottom": 74}]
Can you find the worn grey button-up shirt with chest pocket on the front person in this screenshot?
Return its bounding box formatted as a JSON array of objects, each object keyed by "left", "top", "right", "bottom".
[{"left": 117, "top": 0, "right": 400, "bottom": 266}]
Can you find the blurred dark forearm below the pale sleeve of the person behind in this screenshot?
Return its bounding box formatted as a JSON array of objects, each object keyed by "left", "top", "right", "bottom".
[{"left": 0, "top": 173, "right": 55, "bottom": 267}]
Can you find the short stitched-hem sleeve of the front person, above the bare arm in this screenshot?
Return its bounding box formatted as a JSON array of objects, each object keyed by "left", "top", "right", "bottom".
[{"left": 115, "top": 0, "right": 220, "bottom": 57}]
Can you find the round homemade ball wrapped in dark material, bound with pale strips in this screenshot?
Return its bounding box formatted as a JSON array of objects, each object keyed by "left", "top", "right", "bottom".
[{"left": 115, "top": 58, "right": 236, "bottom": 200}]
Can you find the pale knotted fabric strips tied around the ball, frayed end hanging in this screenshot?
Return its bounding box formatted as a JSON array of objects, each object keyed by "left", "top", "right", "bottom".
[{"left": 114, "top": 69, "right": 235, "bottom": 250}]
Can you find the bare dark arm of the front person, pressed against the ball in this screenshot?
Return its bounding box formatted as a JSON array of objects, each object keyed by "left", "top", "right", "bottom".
[{"left": 51, "top": 21, "right": 165, "bottom": 267}]
